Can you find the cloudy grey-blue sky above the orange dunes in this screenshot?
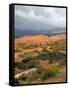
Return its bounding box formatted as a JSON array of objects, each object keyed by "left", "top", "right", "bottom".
[{"left": 15, "top": 5, "right": 66, "bottom": 34}]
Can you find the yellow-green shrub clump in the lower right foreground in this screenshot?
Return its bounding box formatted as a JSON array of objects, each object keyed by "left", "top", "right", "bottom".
[{"left": 36, "top": 65, "right": 59, "bottom": 81}]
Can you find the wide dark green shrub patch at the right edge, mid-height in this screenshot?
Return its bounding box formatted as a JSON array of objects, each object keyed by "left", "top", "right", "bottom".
[{"left": 38, "top": 51, "right": 66, "bottom": 60}]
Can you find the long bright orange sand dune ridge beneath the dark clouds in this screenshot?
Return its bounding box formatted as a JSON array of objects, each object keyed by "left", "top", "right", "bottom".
[{"left": 15, "top": 34, "right": 66, "bottom": 43}]
